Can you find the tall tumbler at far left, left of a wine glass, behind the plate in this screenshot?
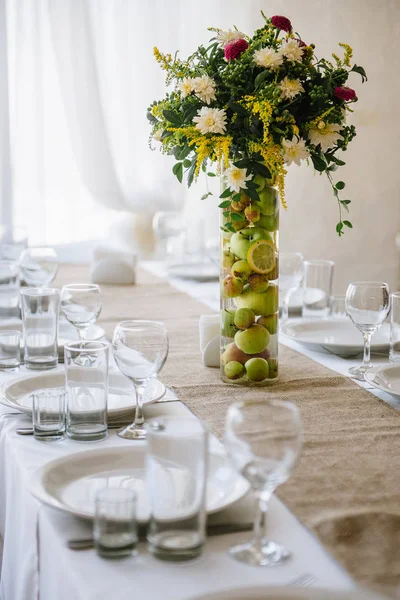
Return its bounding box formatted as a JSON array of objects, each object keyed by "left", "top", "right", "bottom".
[{"left": 21, "top": 288, "right": 60, "bottom": 370}]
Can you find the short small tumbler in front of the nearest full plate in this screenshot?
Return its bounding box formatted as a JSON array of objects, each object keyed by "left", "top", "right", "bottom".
[{"left": 93, "top": 487, "right": 138, "bottom": 558}]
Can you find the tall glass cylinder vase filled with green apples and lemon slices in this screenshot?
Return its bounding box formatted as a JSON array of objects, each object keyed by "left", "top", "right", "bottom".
[{"left": 220, "top": 175, "right": 279, "bottom": 386}]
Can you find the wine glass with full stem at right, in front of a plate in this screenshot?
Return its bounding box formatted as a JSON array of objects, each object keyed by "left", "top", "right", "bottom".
[{"left": 346, "top": 281, "right": 390, "bottom": 381}]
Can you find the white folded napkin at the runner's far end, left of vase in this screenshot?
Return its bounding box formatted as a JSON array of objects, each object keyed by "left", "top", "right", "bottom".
[{"left": 91, "top": 246, "right": 136, "bottom": 285}]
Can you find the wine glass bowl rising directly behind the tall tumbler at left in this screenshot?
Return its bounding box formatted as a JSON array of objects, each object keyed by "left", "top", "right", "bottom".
[{"left": 19, "top": 248, "right": 58, "bottom": 287}]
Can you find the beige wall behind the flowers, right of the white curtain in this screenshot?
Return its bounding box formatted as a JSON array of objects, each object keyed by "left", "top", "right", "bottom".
[{"left": 181, "top": 0, "right": 400, "bottom": 293}]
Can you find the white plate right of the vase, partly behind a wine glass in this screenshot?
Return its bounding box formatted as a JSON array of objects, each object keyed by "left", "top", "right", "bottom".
[{"left": 282, "top": 318, "right": 390, "bottom": 356}]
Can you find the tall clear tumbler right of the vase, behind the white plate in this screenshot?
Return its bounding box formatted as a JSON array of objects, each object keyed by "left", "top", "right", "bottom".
[{"left": 302, "top": 260, "right": 335, "bottom": 318}]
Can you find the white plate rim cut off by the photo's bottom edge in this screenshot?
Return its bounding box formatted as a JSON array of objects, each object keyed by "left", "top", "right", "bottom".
[{"left": 189, "top": 586, "right": 383, "bottom": 600}]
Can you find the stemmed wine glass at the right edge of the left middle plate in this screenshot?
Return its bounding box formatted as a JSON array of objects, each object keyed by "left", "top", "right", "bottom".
[{"left": 112, "top": 320, "right": 168, "bottom": 440}]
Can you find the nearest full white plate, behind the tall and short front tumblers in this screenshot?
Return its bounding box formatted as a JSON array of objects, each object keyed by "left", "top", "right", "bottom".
[{"left": 30, "top": 442, "right": 249, "bottom": 522}]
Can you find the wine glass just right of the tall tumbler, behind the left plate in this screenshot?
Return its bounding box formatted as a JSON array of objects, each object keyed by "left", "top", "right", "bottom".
[{"left": 61, "top": 283, "right": 102, "bottom": 342}]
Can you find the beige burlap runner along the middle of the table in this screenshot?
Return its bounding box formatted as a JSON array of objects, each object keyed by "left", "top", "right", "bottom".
[{"left": 56, "top": 266, "right": 400, "bottom": 597}]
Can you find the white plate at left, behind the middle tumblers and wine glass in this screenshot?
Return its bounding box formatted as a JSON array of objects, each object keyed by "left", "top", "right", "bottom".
[{"left": 0, "top": 371, "right": 166, "bottom": 418}]
